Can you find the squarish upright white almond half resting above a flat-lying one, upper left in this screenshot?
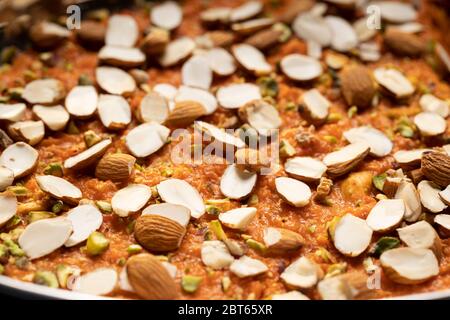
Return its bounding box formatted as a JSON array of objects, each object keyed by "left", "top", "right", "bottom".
[{"left": 105, "top": 14, "right": 139, "bottom": 47}]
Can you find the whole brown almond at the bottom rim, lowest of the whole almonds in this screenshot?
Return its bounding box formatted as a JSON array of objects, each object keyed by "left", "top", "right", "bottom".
[{"left": 126, "top": 253, "right": 178, "bottom": 300}]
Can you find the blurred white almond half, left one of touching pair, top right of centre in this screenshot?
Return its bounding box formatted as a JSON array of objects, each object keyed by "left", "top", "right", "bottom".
[{"left": 292, "top": 13, "right": 332, "bottom": 47}]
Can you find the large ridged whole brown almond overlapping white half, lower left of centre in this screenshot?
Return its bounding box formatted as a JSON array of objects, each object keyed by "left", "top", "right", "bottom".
[{"left": 134, "top": 214, "right": 186, "bottom": 252}]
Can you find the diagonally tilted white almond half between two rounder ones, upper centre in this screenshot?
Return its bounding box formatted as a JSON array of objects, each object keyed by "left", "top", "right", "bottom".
[{"left": 232, "top": 43, "right": 272, "bottom": 75}]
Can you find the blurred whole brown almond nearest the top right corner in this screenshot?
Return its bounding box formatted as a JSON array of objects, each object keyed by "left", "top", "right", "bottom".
[{"left": 384, "top": 29, "right": 425, "bottom": 57}]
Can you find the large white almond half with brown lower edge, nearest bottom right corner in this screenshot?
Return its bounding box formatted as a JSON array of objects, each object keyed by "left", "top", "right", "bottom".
[{"left": 380, "top": 248, "right": 439, "bottom": 284}]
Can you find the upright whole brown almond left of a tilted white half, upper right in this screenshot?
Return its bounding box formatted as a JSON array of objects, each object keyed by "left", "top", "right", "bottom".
[{"left": 341, "top": 66, "right": 375, "bottom": 108}]
